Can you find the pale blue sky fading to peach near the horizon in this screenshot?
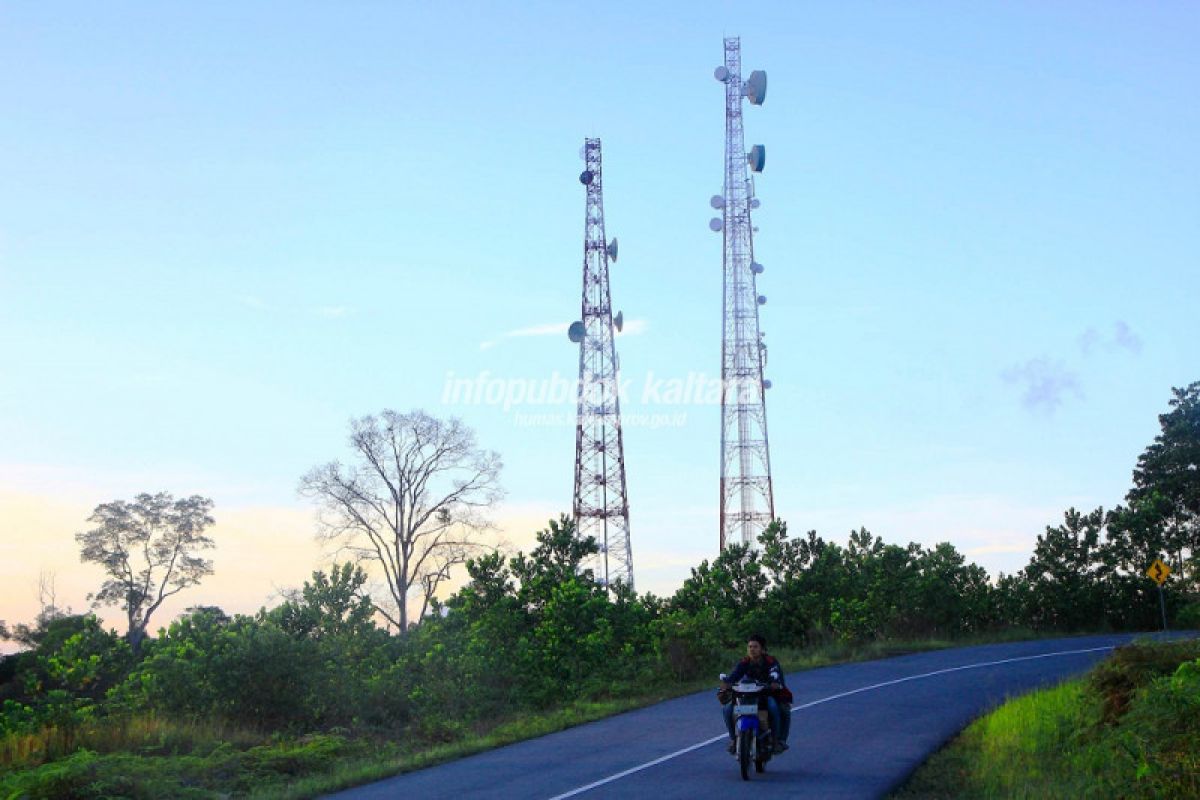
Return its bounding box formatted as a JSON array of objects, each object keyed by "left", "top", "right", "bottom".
[{"left": 0, "top": 0, "right": 1200, "bottom": 652}]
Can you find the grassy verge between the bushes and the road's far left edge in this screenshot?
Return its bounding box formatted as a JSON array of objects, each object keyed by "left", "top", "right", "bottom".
[{"left": 0, "top": 631, "right": 1070, "bottom": 800}]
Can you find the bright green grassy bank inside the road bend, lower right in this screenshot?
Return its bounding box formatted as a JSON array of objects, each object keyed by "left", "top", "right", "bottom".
[{"left": 893, "top": 640, "right": 1200, "bottom": 800}]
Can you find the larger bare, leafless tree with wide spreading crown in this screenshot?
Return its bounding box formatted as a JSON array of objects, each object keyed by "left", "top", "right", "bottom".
[{"left": 300, "top": 409, "right": 500, "bottom": 631}]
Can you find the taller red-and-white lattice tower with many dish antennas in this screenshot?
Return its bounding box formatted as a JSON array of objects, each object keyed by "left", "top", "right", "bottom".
[{"left": 709, "top": 37, "right": 775, "bottom": 549}]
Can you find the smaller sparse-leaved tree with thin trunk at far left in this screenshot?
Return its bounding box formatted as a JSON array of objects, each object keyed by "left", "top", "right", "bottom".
[{"left": 76, "top": 492, "right": 214, "bottom": 652}]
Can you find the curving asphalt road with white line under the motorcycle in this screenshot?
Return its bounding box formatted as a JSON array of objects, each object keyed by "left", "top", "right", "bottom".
[{"left": 331, "top": 636, "right": 1185, "bottom": 800}]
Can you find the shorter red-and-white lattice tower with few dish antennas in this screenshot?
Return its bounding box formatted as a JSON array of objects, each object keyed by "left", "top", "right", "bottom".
[{"left": 569, "top": 139, "right": 634, "bottom": 588}]
